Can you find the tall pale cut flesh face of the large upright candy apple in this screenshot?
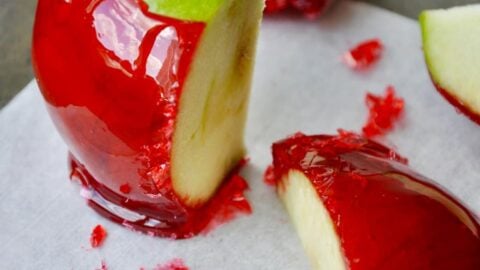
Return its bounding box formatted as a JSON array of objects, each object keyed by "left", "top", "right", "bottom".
[{"left": 171, "top": 0, "right": 264, "bottom": 206}]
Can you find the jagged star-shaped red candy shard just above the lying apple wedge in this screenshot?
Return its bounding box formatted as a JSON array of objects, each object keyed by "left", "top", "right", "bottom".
[{"left": 362, "top": 86, "right": 405, "bottom": 138}]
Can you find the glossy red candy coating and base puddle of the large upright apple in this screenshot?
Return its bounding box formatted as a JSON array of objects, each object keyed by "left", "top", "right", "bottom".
[{"left": 33, "top": 0, "right": 251, "bottom": 238}]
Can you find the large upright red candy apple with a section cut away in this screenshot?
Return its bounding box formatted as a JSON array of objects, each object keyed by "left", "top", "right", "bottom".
[{"left": 33, "top": 0, "right": 264, "bottom": 237}]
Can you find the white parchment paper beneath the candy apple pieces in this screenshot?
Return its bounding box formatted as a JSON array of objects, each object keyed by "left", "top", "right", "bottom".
[{"left": 0, "top": 1, "right": 480, "bottom": 270}]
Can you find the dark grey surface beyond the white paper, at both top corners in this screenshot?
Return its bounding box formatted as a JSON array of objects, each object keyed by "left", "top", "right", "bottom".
[{"left": 0, "top": 0, "right": 479, "bottom": 108}]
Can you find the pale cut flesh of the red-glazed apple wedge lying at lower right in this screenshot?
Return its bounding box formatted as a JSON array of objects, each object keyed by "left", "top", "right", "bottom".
[{"left": 279, "top": 170, "right": 347, "bottom": 270}]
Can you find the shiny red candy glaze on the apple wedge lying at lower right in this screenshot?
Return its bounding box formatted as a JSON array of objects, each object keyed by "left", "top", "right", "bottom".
[{"left": 273, "top": 133, "right": 480, "bottom": 270}]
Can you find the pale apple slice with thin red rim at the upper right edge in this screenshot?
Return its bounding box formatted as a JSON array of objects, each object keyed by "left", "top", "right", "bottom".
[{"left": 420, "top": 5, "right": 480, "bottom": 124}]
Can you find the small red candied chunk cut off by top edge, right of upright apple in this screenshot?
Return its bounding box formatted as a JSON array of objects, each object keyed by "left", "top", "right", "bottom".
[{"left": 265, "top": 0, "right": 333, "bottom": 19}]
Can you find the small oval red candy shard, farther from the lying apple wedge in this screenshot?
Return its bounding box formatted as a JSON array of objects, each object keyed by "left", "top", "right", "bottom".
[{"left": 343, "top": 39, "right": 383, "bottom": 69}]
